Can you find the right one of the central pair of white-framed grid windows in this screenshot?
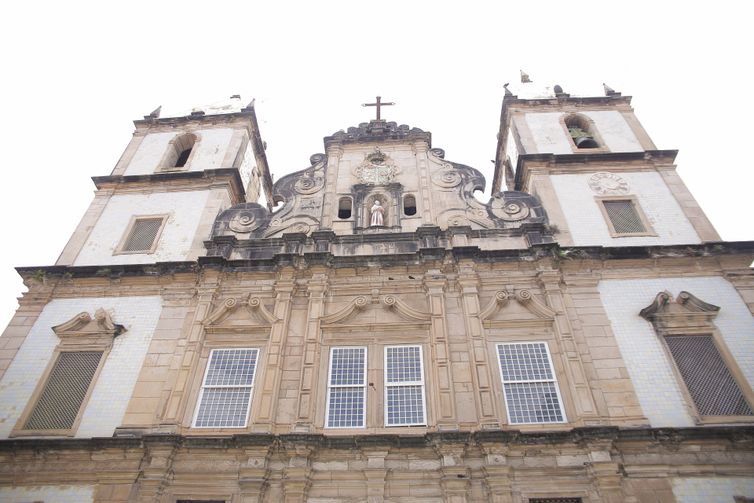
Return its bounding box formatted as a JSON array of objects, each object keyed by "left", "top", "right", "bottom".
[{"left": 385, "top": 346, "right": 427, "bottom": 426}]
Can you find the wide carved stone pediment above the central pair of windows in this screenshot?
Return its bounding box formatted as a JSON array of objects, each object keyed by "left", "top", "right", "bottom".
[{"left": 320, "top": 295, "right": 431, "bottom": 330}]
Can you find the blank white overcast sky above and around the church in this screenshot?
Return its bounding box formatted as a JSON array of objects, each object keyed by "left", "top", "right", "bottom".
[{"left": 0, "top": 0, "right": 754, "bottom": 329}]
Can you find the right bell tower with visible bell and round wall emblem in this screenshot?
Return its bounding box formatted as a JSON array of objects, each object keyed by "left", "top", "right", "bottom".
[{"left": 493, "top": 83, "right": 720, "bottom": 247}]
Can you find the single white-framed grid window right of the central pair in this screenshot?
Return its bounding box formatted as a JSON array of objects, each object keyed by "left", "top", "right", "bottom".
[{"left": 497, "top": 342, "right": 566, "bottom": 424}]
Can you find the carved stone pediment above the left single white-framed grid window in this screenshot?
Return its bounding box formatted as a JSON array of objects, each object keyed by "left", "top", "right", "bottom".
[{"left": 202, "top": 297, "right": 279, "bottom": 332}]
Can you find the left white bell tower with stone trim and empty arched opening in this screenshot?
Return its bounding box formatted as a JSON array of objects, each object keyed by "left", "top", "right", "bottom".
[{"left": 57, "top": 95, "right": 272, "bottom": 267}]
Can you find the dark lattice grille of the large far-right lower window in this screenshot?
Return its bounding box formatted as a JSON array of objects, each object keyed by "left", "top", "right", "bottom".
[{"left": 665, "top": 335, "right": 754, "bottom": 416}]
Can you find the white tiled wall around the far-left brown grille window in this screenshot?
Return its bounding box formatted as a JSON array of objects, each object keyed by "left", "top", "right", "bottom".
[{"left": 0, "top": 296, "right": 162, "bottom": 438}]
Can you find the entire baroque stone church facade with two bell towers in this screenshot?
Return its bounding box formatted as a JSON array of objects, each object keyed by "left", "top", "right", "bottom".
[{"left": 0, "top": 87, "right": 754, "bottom": 503}]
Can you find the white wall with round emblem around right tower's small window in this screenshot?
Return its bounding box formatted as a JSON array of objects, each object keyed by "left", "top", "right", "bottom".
[{"left": 545, "top": 172, "right": 701, "bottom": 246}]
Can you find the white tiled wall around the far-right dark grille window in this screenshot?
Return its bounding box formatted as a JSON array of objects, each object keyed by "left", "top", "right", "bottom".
[{"left": 599, "top": 277, "right": 754, "bottom": 427}]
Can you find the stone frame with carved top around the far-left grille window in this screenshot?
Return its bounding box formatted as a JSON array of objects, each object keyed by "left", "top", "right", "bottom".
[{"left": 10, "top": 308, "right": 126, "bottom": 437}]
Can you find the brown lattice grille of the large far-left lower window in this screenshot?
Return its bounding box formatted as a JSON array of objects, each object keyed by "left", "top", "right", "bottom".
[{"left": 24, "top": 351, "right": 102, "bottom": 430}]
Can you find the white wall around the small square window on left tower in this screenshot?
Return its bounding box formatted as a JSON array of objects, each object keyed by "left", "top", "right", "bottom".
[{"left": 73, "top": 190, "right": 210, "bottom": 266}]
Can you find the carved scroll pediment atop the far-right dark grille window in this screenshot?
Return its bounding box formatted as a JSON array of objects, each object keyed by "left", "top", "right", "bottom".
[{"left": 639, "top": 291, "right": 720, "bottom": 335}]
